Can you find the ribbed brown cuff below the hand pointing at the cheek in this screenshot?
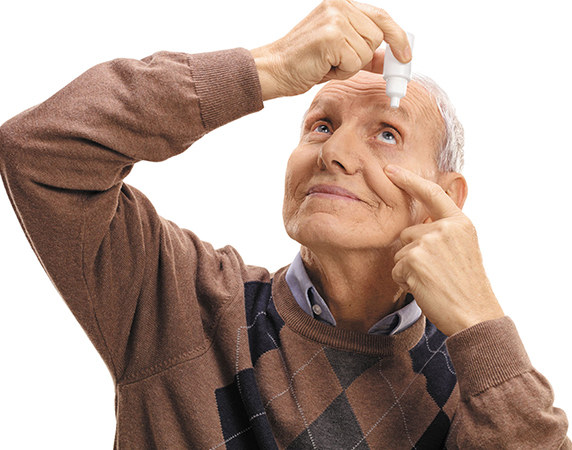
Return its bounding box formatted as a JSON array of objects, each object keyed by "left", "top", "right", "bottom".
[{"left": 447, "top": 316, "right": 532, "bottom": 399}]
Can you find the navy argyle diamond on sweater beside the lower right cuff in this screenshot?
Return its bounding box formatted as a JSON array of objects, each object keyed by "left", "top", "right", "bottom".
[{"left": 409, "top": 321, "right": 457, "bottom": 408}]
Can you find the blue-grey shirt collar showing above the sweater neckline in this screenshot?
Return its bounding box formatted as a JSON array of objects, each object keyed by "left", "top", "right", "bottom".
[{"left": 286, "top": 253, "right": 421, "bottom": 335}]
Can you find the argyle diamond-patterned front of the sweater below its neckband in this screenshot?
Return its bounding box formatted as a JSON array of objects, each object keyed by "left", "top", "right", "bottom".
[{"left": 221, "top": 282, "right": 456, "bottom": 449}]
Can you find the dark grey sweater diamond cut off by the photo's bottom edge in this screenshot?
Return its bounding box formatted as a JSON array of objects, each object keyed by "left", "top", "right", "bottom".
[{"left": 288, "top": 392, "right": 369, "bottom": 450}]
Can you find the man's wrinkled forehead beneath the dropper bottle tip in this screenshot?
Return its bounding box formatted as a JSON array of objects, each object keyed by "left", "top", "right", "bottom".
[{"left": 310, "top": 71, "right": 444, "bottom": 135}]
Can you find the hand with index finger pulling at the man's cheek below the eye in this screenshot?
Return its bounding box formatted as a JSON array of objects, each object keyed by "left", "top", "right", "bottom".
[{"left": 385, "top": 166, "right": 504, "bottom": 336}]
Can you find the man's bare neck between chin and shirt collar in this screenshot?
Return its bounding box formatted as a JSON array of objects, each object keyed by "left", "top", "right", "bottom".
[{"left": 300, "top": 246, "right": 405, "bottom": 333}]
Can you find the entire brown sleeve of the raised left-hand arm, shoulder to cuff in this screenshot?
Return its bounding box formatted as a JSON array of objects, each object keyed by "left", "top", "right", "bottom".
[{"left": 0, "top": 49, "right": 262, "bottom": 381}]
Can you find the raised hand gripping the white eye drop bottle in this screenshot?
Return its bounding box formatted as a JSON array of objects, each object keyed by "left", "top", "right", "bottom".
[{"left": 251, "top": 0, "right": 411, "bottom": 100}]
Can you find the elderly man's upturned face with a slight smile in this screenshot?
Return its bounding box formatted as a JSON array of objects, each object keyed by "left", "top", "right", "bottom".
[{"left": 283, "top": 72, "right": 443, "bottom": 250}]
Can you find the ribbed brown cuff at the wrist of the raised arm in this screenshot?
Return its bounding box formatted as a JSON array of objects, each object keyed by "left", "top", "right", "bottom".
[{"left": 189, "top": 48, "right": 263, "bottom": 131}]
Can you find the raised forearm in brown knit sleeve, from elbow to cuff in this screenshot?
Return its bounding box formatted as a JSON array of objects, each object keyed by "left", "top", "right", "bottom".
[{"left": 0, "top": 49, "right": 262, "bottom": 191}]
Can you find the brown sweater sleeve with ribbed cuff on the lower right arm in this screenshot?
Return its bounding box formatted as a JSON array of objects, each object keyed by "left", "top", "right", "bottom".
[{"left": 447, "top": 317, "right": 572, "bottom": 449}]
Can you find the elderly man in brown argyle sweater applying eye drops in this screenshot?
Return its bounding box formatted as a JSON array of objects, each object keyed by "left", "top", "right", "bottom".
[{"left": 0, "top": 0, "right": 571, "bottom": 449}]
